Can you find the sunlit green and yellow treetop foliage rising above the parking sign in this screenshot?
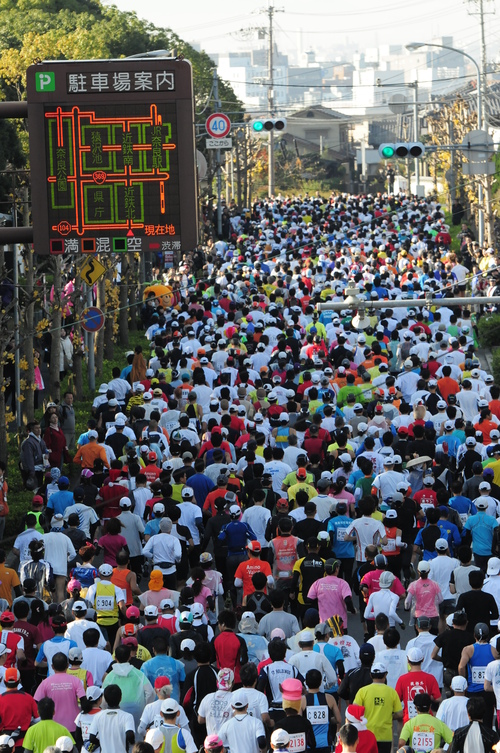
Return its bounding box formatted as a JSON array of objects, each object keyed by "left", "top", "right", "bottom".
[{"left": 0, "top": 0, "right": 242, "bottom": 122}]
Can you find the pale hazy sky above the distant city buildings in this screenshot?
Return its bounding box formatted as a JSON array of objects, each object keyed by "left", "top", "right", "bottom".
[{"left": 105, "top": 0, "right": 500, "bottom": 59}]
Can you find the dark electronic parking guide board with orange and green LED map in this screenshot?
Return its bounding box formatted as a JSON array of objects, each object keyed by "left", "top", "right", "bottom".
[{"left": 28, "top": 61, "right": 196, "bottom": 262}]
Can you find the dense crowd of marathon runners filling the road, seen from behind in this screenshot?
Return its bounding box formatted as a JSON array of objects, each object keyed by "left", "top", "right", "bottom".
[{"left": 5, "top": 189, "right": 500, "bottom": 753}]
